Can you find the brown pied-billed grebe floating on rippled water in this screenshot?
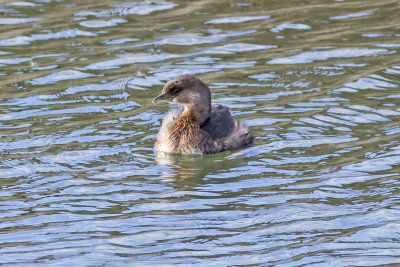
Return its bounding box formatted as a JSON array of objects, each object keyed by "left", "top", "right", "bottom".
[{"left": 153, "top": 75, "right": 254, "bottom": 154}]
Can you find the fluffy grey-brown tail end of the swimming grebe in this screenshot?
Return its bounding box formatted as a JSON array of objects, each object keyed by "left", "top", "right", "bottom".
[{"left": 219, "top": 120, "right": 254, "bottom": 150}]
